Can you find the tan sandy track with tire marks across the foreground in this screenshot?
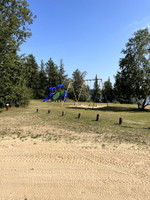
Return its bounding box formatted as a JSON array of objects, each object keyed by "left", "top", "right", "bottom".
[{"left": 0, "top": 139, "right": 150, "bottom": 200}]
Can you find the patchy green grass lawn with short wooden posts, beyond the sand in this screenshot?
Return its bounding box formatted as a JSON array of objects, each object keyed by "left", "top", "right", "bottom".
[{"left": 0, "top": 100, "right": 150, "bottom": 147}]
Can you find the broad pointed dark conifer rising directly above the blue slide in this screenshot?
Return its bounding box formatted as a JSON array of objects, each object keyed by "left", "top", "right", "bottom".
[{"left": 46, "top": 58, "right": 59, "bottom": 88}]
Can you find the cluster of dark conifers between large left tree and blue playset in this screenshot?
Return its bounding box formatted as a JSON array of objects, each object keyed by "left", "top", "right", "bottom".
[{"left": 23, "top": 54, "right": 67, "bottom": 99}]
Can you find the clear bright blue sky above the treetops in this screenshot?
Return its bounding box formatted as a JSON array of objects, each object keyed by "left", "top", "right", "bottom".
[{"left": 20, "top": 0, "right": 150, "bottom": 83}]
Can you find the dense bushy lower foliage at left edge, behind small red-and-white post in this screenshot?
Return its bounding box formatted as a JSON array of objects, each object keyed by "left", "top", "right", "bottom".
[{"left": 0, "top": 54, "right": 30, "bottom": 107}]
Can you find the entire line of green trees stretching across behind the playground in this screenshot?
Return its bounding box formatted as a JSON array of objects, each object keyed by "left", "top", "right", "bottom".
[{"left": 0, "top": 0, "right": 150, "bottom": 110}]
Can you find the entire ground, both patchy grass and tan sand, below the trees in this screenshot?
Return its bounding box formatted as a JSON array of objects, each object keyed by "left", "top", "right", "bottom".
[{"left": 0, "top": 100, "right": 150, "bottom": 200}]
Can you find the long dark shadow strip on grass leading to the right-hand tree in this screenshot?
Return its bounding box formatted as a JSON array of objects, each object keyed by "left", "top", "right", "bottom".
[{"left": 67, "top": 106, "right": 150, "bottom": 113}]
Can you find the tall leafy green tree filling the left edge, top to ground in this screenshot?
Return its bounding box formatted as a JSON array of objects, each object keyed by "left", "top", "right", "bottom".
[{"left": 0, "top": 0, "right": 33, "bottom": 107}]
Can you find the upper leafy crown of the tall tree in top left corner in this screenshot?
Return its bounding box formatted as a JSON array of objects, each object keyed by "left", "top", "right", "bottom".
[{"left": 0, "top": 0, "right": 33, "bottom": 50}]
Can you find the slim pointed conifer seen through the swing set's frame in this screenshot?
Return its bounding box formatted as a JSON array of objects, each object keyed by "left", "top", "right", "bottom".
[{"left": 92, "top": 75, "right": 101, "bottom": 103}]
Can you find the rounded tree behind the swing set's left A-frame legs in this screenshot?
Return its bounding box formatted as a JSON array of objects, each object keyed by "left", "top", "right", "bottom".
[{"left": 69, "top": 69, "right": 89, "bottom": 101}]
